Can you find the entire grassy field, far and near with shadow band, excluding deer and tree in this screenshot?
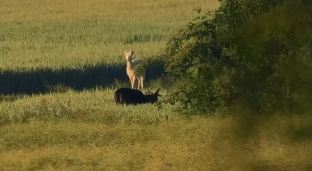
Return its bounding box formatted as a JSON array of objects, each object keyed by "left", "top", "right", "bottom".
[{"left": 0, "top": 0, "right": 312, "bottom": 171}]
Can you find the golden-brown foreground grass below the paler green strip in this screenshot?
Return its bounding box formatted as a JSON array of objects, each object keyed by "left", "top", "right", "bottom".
[{"left": 0, "top": 116, "right": 312, "bottom": 170}]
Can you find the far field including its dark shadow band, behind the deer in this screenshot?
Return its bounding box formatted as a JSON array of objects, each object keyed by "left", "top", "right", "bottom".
[{"left": 0, "top": 0, "right": 219, "bottom": 94}]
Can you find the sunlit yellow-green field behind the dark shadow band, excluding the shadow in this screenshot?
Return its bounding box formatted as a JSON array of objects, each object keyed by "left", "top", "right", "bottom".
[{"left": 0, "top": 0, "right": 218, "bottom": 70}]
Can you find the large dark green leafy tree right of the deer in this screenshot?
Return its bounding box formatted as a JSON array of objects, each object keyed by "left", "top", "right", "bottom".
[{"left": 164, "top": 0, "right": 312, "bottom": 114}]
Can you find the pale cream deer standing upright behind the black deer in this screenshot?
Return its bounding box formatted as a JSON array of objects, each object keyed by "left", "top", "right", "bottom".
[{"left": 124, "top": 50, "right": 144, "bottom": 89}]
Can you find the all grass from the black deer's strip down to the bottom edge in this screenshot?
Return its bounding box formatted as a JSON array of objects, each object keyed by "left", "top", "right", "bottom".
[{"left": 0, "top": 90, "right": 312, "bottom": 170}]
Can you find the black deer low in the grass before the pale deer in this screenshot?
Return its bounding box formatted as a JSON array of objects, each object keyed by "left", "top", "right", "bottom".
[{"left": 115, "top": 88, "right": 161, "bottom": 105}]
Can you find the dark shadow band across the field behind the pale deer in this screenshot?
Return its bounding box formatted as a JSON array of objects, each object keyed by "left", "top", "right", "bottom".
[{"left": 0, "top": 64, "right": 164, "bottom": 95}]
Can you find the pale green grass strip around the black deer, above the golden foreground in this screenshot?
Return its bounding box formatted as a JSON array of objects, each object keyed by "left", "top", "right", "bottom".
[{"left": 0, "top": 89, "right": 174, "bottom": 124}]
